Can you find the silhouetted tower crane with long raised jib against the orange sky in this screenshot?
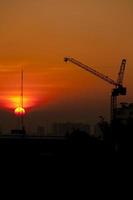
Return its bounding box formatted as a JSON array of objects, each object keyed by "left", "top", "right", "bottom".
[{"left": 64, "top": 57, "right": 126, "bottom": 122}]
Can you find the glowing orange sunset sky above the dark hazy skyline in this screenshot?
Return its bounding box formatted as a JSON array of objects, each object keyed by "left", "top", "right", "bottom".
[{"left": 0, "top": 0, "right": 133, "bottom": 131}]
